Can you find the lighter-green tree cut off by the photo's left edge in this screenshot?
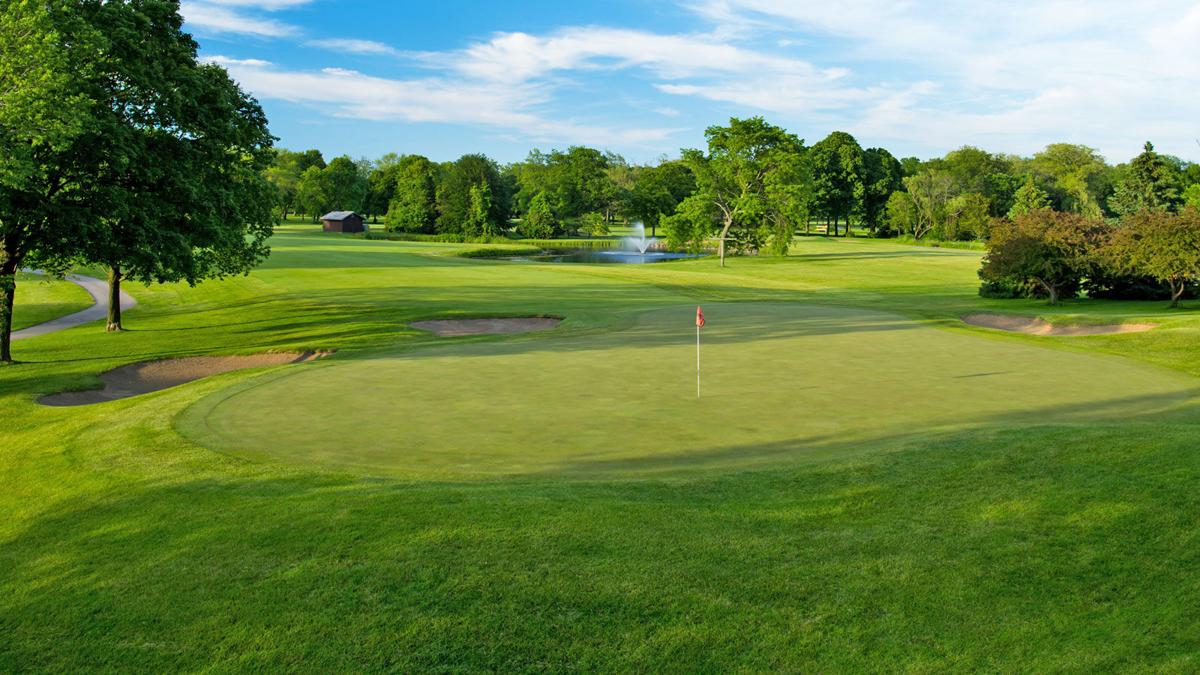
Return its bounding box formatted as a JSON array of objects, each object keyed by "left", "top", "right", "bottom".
[{"left": 0, "top": 0, "right": 103, "bottom": 363}]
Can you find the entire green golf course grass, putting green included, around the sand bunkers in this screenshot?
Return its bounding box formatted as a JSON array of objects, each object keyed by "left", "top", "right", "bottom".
[{"left": 0, "top": 226, "right": 1200, "bottom": 673}]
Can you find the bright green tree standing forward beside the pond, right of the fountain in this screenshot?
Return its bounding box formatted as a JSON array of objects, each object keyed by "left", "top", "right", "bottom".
[{"left": 680, "top": 118, "right": 804, "bottom": 267}]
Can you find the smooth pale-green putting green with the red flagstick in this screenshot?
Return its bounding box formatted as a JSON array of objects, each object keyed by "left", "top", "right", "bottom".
[{"left": 178, "top": 304, "right": 1196, "bottom": 478}]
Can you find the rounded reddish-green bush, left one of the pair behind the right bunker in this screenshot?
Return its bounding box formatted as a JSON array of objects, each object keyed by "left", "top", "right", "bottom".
[{"left": 979, "top": 209, "right": 1103, "bottom": 305}]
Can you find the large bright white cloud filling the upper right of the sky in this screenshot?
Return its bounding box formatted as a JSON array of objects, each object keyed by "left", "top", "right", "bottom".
[{"left": 691, "top": 0, "right": 1200, "bottom": 161}]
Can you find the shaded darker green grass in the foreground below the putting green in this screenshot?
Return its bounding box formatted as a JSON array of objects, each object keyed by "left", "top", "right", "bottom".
[{"left": 0, "top": 425, "right": 1200, "bottom": 671}]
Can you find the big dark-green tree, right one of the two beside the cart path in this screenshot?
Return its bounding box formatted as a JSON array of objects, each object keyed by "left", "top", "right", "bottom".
[{"left": 77, "top": 1, "right": 276, "bottom": 331}]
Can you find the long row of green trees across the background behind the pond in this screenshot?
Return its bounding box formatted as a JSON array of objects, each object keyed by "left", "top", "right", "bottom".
[{"left": 268, "top": 118, "right": 1200, "bottom": 263}]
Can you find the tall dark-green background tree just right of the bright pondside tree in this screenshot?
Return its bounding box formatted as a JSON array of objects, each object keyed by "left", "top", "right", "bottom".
[{"left": 809, "top": 131, "right": 866, "bottom": 237}]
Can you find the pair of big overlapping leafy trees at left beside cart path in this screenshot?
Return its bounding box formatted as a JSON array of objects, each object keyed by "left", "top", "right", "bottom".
[{"left": 0, "top": 0, "right": 277, "bottom": 363}]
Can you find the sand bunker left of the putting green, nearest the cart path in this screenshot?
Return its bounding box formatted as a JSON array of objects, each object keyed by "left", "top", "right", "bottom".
[{"left": 37, "top": 352, "right": 328, "bottom": 406}]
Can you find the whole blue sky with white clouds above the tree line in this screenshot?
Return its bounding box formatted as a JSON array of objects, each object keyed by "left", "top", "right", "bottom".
[{"left": 182, "top": 0, "right": 1200, "bottom": 162}]
